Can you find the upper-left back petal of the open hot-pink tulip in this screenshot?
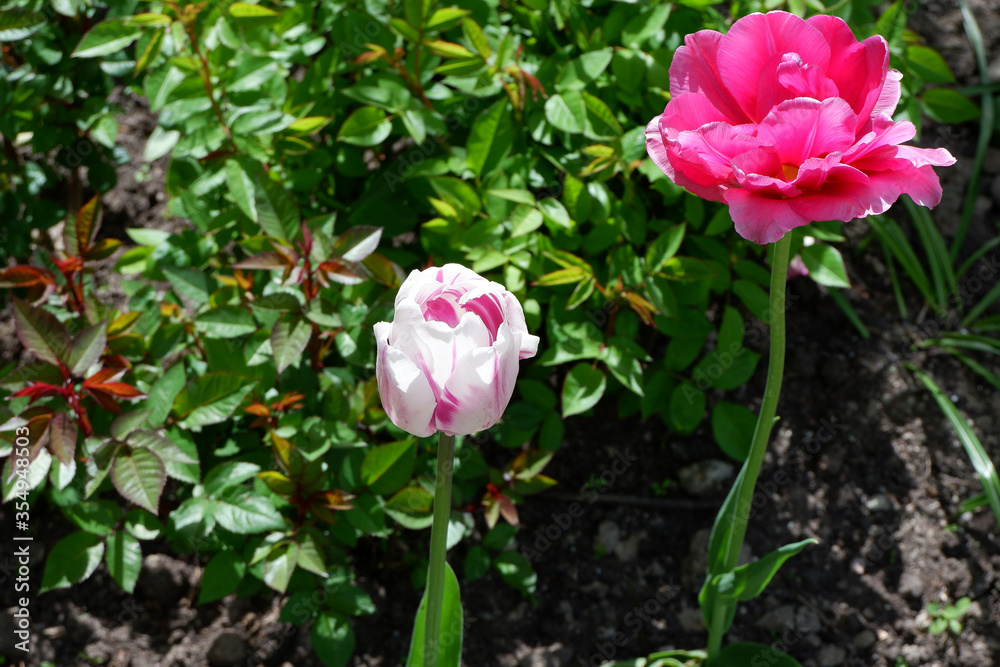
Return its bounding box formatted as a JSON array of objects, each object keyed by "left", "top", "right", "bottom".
[{"left": 670, "top": 30, "right": 749, "bottom": 123}]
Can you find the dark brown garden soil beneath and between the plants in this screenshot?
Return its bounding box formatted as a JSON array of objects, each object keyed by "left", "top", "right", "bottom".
[{"left": 0, "top": 0, "right": 1000, "bottom": 667}]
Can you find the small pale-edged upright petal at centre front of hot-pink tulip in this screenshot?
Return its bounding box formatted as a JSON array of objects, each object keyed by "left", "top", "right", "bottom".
[{"left": 758, "top": 97, "right": 857, "bottom": 167}]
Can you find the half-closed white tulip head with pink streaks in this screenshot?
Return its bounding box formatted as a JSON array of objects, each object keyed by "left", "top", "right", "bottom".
[{"left": 374, "top": 264, "right": 538, "bottom": 437}]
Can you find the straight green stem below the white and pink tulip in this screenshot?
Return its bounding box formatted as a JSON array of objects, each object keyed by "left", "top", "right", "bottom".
[{"left": 424, "top": 433, "right": 455, "bottom": 667}]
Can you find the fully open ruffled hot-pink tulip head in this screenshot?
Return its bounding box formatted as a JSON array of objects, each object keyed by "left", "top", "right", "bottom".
[{"left": 646, "top": 11, "right": 955, "bottom": 243}]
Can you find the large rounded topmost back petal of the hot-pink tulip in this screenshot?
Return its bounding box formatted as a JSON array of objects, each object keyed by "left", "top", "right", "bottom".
[{"left": 720, "top": 11, "right": 830, "bottom": 122}]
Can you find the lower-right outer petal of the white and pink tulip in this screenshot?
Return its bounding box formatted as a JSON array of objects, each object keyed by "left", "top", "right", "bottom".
[{"left": 434, "top": 324, "right": 518, "bottom": 435}]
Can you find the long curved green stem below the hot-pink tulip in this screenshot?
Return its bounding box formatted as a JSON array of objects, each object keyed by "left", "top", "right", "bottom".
[{"left": 708, "top": 233, "right": 792, "bottom": 664}]
